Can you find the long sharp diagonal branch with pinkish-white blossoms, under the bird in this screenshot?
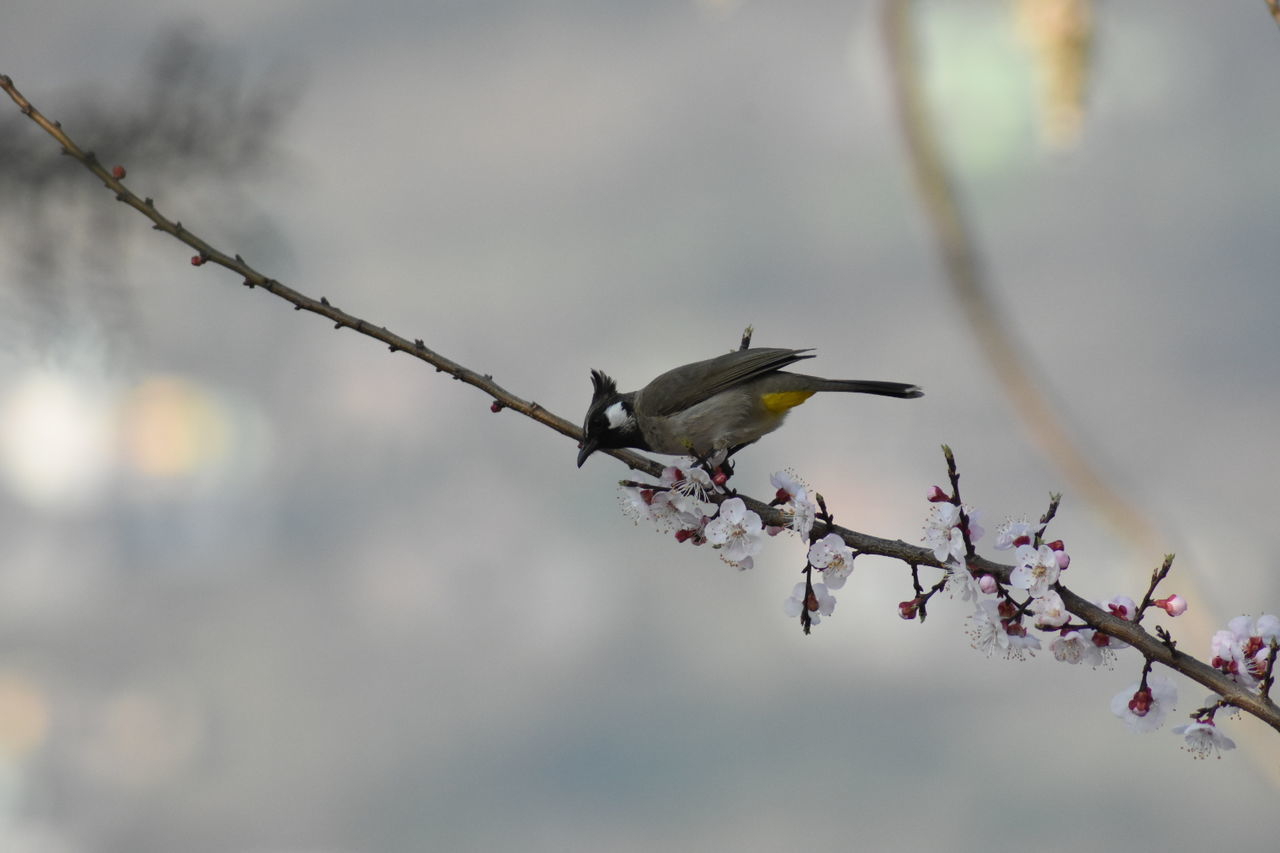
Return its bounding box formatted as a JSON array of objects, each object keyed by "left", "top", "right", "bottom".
[{"left": 0, "top": 76, "right": 1280, "bottom": 749}]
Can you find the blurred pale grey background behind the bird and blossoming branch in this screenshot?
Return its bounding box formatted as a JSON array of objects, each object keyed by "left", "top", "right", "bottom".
[{"left": 0, "top": 0, "right": 1280, "bottom": 853}]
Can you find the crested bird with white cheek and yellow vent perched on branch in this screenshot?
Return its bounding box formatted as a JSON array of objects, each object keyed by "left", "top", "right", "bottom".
[{"left": 577, "top": 347, "right": 924, "bottom": 467}]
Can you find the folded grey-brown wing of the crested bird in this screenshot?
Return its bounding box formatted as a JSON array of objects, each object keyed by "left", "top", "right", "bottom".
[{"left": 636, "top": 347, "right": 813, "bottom": 416}]
